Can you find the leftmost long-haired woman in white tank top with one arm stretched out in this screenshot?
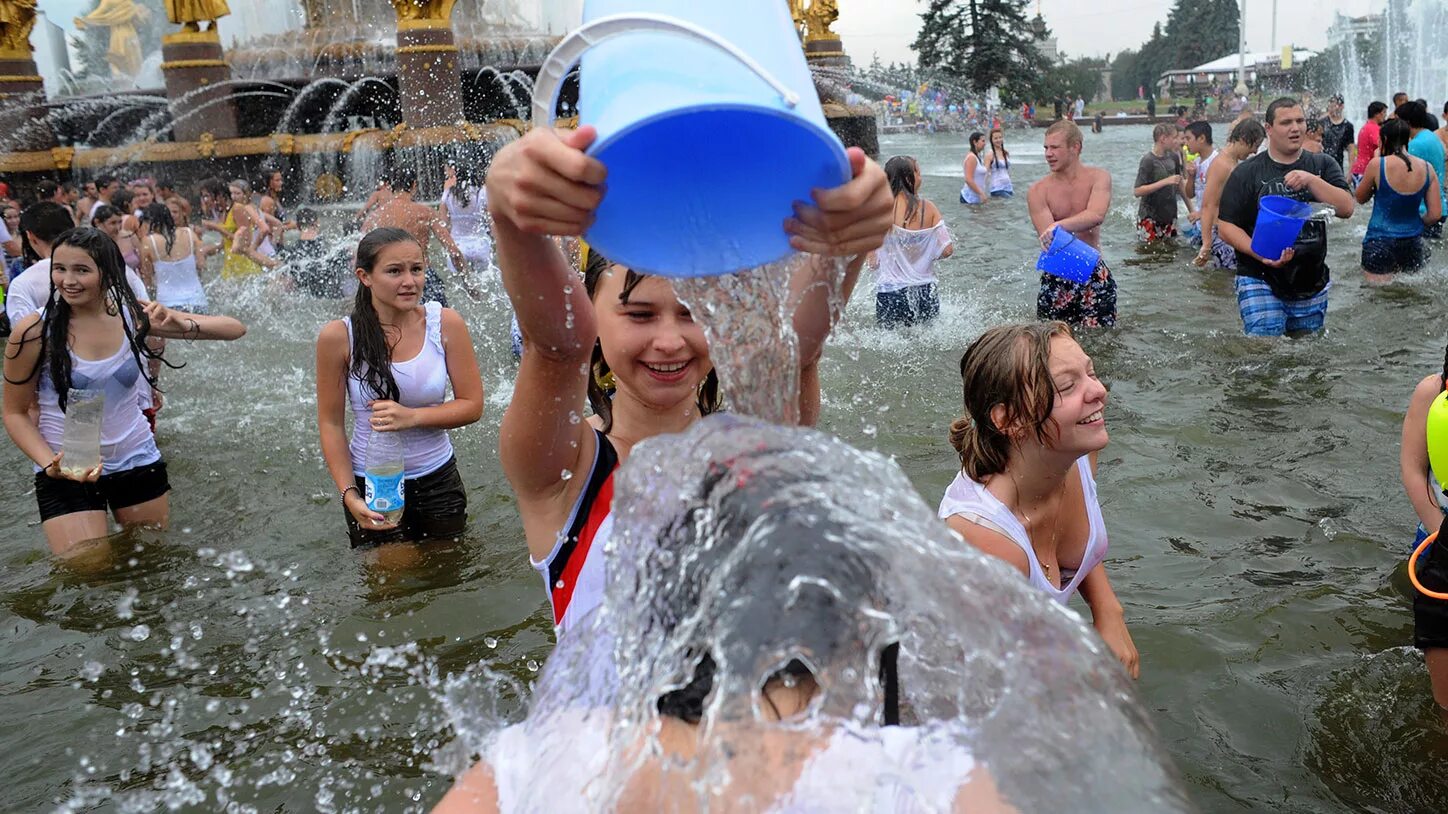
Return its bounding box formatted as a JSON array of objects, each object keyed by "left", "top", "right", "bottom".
[{"left": 4, "top": 227, "right": 246, "bottom": 556}]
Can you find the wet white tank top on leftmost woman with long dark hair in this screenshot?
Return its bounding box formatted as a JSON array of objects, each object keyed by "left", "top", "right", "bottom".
[{"left": 35, "top": 324, "right": 161, "bottom": 475}]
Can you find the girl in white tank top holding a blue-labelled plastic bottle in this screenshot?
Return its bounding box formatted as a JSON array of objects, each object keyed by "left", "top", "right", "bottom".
[{"left": 317, "top": 227, "right": 482, "bottom": 547}]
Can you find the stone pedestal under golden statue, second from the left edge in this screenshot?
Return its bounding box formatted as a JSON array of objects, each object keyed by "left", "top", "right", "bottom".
[{"left": 161, "top": 26, "right": 237, "bottom": 142}]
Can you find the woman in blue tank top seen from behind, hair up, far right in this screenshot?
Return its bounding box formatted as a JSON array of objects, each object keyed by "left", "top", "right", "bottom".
[{"left": 1354, "top": 119, "right": 1442, "bottom": 284}]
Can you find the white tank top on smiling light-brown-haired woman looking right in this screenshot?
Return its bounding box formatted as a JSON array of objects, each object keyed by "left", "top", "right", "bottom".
[{"left": 940, "top": 455, "right": 1108, "bottom": 604}]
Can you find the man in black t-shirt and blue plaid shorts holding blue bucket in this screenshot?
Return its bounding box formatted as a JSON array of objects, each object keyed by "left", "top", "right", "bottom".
[{"left": 1218, "top": 97, "right": 1354, "bottom": 336}]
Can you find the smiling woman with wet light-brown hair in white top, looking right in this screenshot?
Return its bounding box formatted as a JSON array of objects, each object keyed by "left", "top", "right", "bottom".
[{"left": 940, "top": 322, "right": 1141, "bottom": 678}]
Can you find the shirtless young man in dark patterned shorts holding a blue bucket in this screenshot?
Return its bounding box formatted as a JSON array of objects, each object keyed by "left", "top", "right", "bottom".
[{"left": 1025, "top": 122, "right": 1116, "bottom": 327}]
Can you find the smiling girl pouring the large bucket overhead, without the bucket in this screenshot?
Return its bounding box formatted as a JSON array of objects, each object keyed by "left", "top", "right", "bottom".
[{"left": 488, "top": 126, "right": 892, "bottom": 634}]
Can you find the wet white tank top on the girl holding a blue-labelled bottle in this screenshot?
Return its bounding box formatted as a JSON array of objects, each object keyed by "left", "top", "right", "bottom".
[{"left": 342, "top": 303, "right": 453, "bottom": 479}]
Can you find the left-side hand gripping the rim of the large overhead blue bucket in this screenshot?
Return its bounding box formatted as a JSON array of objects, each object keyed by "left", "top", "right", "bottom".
[{"left": 488, "top": 126, "right": 608, "bottom": 236}]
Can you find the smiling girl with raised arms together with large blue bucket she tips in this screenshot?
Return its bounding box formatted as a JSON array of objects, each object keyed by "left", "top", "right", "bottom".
[{"left": 487, "top": 0, "right": 893, "bottom": 634}]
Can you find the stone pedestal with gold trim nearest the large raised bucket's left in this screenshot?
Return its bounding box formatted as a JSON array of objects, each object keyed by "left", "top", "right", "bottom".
[{"left": 397, "top": 20, "right": 463, "bottom": 129}]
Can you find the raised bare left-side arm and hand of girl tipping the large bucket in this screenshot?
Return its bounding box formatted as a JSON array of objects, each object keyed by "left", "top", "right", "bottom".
[{"left": 488, "top": 127, "right": 607, "bottom": 527}]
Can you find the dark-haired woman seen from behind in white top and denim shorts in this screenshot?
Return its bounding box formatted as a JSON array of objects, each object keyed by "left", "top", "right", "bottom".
[{"left": 869, "top": 155, "right": 956, "bottom": 327}]
